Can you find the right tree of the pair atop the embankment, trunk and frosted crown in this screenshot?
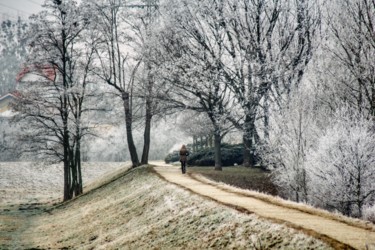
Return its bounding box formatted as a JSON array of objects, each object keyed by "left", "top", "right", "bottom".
[{"left": 124, "top": 0, "right": 164, "bottom": 164}]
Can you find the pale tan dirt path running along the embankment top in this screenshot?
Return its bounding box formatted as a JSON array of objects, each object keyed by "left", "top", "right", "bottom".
[{"left": 152, "top": 162, "right": 375, "bottom": 249}]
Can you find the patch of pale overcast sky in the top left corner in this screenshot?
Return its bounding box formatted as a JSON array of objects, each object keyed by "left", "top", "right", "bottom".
[{"left": 0, "top": 0, "right": 45, "bottom": 19}]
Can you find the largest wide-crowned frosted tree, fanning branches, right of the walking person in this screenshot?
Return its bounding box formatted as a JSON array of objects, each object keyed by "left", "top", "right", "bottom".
[{"left": 156, "top": 0, "right": 320, "bottom": 169}]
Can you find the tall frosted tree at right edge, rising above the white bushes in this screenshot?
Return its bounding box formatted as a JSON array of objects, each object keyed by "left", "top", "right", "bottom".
[{"left": 323, "top": 0, "right": 375, "bottom": 116}]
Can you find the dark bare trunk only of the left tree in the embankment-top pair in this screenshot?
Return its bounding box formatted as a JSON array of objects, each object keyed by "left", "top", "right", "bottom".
[{"left": 122, "top": 92, "right": 139, "bottom": 168}]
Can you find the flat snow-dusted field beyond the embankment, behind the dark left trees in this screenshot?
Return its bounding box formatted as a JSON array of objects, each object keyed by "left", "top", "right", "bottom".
[{"left": 0, "top": 162, "right": 131, "bottom": 205}]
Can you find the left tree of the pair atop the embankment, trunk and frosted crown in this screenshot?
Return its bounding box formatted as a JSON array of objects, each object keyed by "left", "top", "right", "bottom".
[{"left": 93, "top": 0, "right": 142, "bottom": 167}]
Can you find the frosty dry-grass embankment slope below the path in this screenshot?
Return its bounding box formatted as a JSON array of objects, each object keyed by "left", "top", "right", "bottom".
[{"left": 0, "top": 167, "right": 328, "bottom": 249}]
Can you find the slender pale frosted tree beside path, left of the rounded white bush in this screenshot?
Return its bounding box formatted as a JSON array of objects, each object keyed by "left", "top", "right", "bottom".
[{"left": 260, "top": 86, "right": 320, "bottom": 202}]
